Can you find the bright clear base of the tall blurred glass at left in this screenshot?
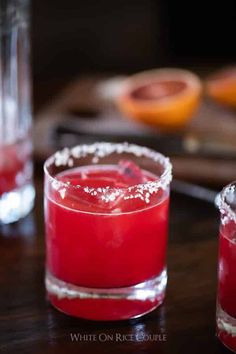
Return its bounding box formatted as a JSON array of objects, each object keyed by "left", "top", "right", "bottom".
[{"left": 0, "top": 184, "right": 35, "bottom": 224}]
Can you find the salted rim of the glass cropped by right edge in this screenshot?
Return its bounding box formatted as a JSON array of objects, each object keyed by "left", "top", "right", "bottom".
[{"left": 217, "top": 181, "right": 236, "bottom": 222}]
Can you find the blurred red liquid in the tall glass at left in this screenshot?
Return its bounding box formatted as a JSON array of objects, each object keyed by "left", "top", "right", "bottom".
[{"left": 0, "top": 141, "right": 31, "bottom": 197}]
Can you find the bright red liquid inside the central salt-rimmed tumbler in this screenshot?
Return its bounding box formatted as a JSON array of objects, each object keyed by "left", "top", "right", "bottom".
[{"left": 45, "top": 164, "right": 169, "bottom": 320}]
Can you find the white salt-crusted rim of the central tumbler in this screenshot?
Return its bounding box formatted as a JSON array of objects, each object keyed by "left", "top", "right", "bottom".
[{"left": 44, "top": 142, "right": 172, "bottom": 201}]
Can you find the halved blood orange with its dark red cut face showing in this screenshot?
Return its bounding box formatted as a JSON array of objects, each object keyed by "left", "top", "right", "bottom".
[{"left": 117, "top": 68, "right": 202, "bottom": 130}]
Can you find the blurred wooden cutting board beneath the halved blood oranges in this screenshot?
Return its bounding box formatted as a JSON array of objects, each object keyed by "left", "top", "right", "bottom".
[{"left": 33, "top": 77, "right": 236, "bottom": 186}]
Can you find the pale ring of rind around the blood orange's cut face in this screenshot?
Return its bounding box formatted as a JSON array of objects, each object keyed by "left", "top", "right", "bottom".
[{"left": 118, "top": 68, "right": 202, "bottom": 106}]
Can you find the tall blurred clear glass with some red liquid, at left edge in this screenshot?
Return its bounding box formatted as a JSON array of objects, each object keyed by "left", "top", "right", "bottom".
[{"left": 0, "top": 0, "right": 35, "bottom": 224}]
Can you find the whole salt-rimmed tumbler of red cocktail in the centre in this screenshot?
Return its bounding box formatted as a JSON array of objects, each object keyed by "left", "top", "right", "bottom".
[{"left": 45, "top": 143, "right": 171, "bottom": 320}]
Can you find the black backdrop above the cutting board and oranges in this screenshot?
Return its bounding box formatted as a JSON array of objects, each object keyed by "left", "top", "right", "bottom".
[{"left": 32, "top": 0, "right": 236, "bottom": 80}]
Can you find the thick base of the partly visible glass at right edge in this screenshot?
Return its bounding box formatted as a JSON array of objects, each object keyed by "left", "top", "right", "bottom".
[{"left": 216, "top": 304, "right": 236, "bottom": 353}]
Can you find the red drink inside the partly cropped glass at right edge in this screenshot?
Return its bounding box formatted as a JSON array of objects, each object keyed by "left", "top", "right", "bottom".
[{"left": 217, "top": 221, "right": 236, "bottom": 351}]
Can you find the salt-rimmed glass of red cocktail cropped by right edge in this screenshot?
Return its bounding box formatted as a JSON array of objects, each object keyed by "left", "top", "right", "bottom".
[{"left": 217, "top": 183, "right": 236, "bottom": 352}]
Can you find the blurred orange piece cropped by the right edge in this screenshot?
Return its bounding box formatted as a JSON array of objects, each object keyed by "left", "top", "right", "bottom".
[{"left": 205, "top": 67, "right": 236, "bottom": 108}]
